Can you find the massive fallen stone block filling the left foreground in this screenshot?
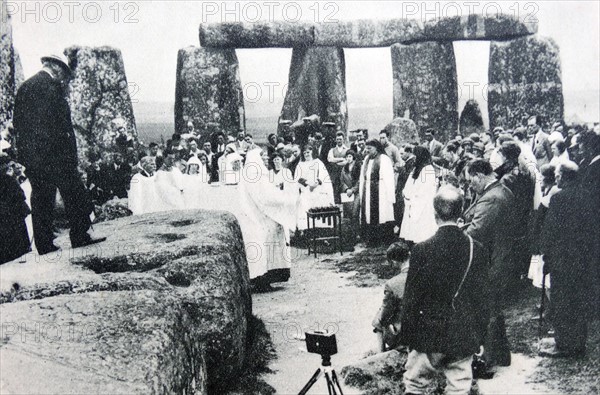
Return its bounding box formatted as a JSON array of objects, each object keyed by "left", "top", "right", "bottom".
[{"left": 0, "top": 210, "right": 252, "bottom": 394}]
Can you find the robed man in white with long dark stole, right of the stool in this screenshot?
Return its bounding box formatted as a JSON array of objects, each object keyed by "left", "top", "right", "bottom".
[{"left": 360, "top": 140, "right": 396, "bottom": 244}]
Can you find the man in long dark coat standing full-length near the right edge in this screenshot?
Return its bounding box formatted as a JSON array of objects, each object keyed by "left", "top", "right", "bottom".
[{"left": 540, "top": 162, "right": 598, "bottom": 357}]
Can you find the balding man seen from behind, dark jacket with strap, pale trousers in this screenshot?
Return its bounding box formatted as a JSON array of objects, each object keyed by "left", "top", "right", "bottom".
[{"left": 400, "top": 186, "right": 489, "bottom": 394}]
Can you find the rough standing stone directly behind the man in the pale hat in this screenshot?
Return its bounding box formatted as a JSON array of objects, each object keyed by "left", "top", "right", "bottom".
[{"left": 65, "top": 46, "right": 137, "bottom": 168}]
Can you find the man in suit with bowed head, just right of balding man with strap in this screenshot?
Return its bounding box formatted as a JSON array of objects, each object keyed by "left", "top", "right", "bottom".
[{"left": 463, "top": 159, "right": 516, "bottom": 367}]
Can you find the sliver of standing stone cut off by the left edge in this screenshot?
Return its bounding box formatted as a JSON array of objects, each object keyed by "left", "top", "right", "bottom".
[{"left": 0, "top": 0, "right": 16, "bottom": 131}]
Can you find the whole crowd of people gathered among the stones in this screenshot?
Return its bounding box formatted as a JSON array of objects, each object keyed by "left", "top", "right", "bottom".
[{"left": 0, "top": 52, "right": 600, "bottom": 393}]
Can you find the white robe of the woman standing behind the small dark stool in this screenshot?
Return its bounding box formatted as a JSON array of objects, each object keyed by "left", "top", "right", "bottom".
[{"left": 294, "top": 159, "right": 334, "bottom": 230}]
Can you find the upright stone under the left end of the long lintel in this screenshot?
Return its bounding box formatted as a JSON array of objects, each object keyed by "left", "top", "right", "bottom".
[{"left": 175, "top": 47, "right": 246, "bottom": 136}]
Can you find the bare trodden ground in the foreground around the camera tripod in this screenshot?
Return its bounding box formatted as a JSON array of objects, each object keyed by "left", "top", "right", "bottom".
[{"left": 246, "top": 248, "right": 600, "bottom": 395}]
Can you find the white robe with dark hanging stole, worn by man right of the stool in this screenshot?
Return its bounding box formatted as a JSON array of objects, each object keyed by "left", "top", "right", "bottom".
[{"left": 359, "top": 154, "right": 396, "bottom": 225}]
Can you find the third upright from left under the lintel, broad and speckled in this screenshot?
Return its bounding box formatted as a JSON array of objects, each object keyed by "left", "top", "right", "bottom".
[{"left": 391, "top": 42, "right": 458, "bottom": 141}]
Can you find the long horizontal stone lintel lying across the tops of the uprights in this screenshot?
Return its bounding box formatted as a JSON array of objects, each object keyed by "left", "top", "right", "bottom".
[{"left": 200, "top": 14, "right": 538, "bottom": 48}]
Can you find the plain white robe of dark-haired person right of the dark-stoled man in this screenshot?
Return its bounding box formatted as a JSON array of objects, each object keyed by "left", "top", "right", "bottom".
[{"left": 400, "top": 165, "right": 438, "bottom": 243}]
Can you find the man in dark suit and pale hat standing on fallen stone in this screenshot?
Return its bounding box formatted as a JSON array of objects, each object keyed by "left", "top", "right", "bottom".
[{"left": 14, "top": 55, "right": 106, "bottom": 255}]
